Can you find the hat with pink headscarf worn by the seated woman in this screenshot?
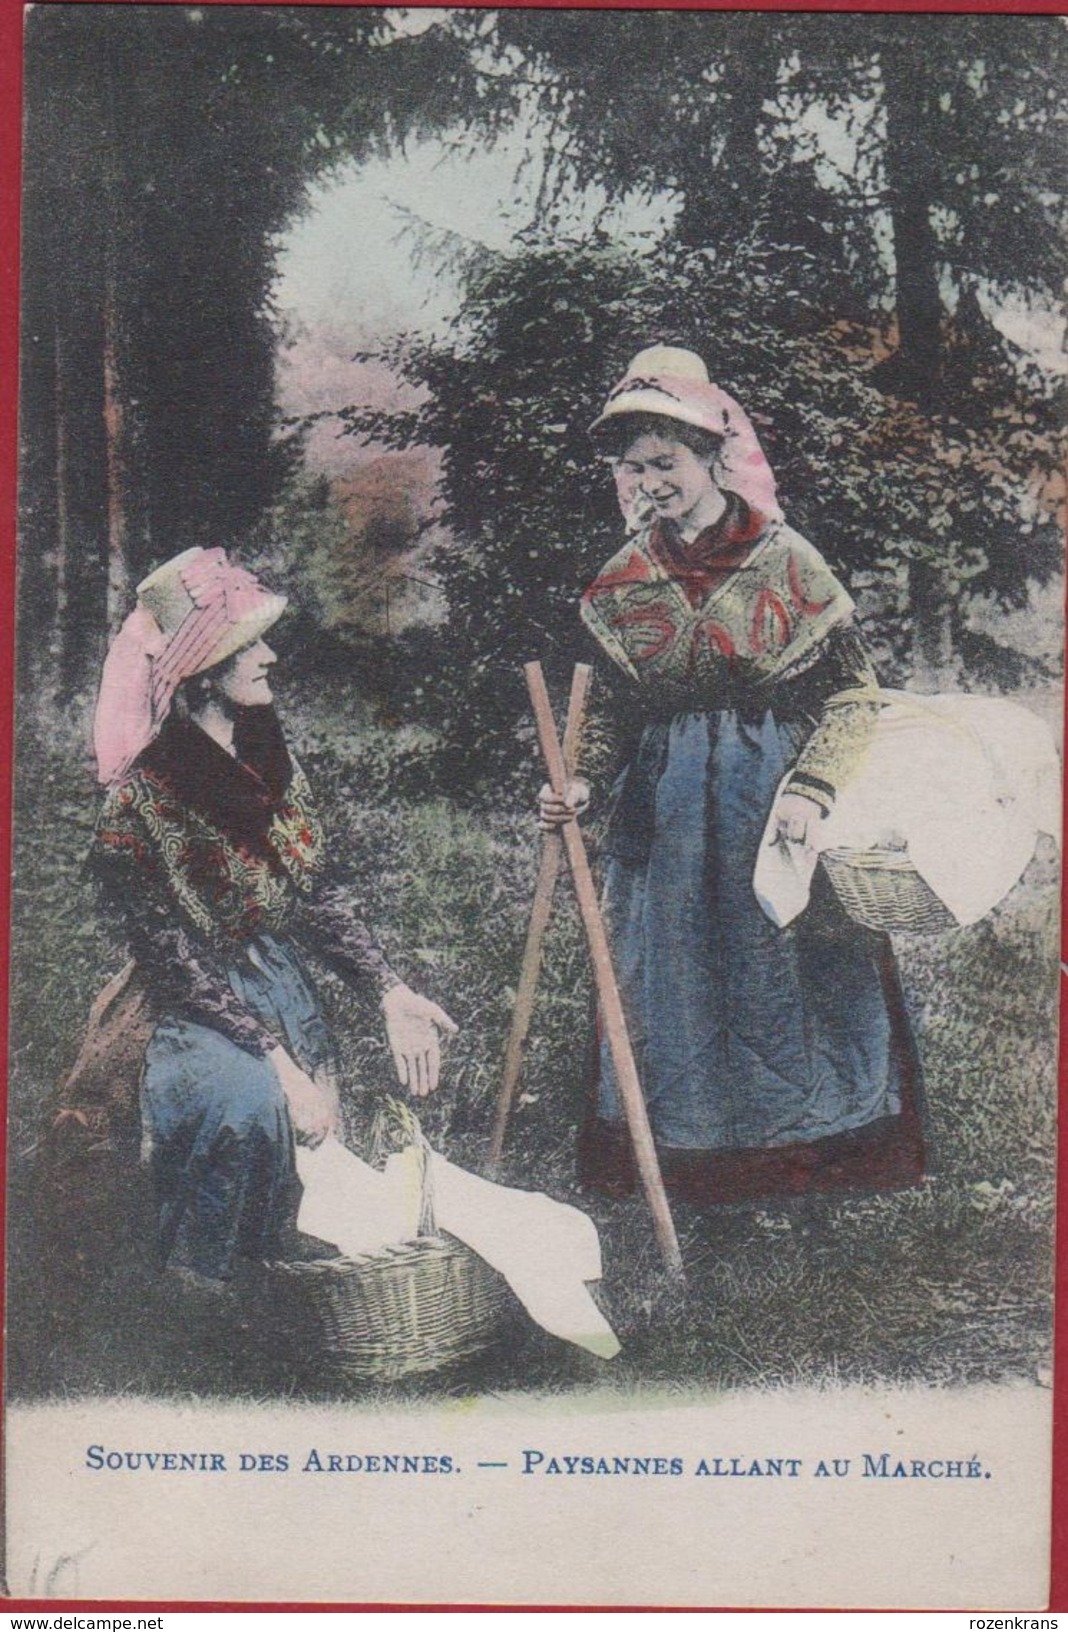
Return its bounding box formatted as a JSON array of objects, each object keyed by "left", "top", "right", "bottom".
[{"left": 93, "top": 550, "right": 286, "bottom": 785}]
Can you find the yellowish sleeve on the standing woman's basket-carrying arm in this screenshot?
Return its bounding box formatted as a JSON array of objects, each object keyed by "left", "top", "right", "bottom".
[{"left": 782, "top": 625, "right": 879, "bottom": 811}]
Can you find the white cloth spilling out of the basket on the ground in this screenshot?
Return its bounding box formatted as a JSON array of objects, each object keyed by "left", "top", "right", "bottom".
[{"left": 297, "top": 1138, "right": 619, "bottom": 1359}]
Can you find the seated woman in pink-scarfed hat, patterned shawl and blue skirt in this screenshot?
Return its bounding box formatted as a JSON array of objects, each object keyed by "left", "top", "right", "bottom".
[{"left": 91, "top": 548, "right": 456, "bottom": 1283}]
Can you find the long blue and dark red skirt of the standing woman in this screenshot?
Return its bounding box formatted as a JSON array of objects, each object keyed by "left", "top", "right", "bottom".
[{"left": 581, "top": 710, "right": 923, "bottom": 1203}]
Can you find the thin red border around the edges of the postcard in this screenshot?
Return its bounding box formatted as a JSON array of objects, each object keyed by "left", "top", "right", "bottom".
[{"left": 0, "top": 0, "right": 1068, "bottom": 1614}]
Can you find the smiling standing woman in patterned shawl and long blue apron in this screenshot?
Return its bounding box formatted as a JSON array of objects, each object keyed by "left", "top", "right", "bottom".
[{"left": 541, "top": 346, "right": 924, "bottom": 1204}]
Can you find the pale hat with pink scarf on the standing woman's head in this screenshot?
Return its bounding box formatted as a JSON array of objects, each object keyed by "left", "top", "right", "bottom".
[{"left": 590, "top": 346, "right": 782, "bottom": 532}]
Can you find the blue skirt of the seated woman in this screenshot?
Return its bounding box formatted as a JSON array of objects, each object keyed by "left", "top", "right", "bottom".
[{"left": 142, "top": 935, "right": 333, "bottom": 1281}]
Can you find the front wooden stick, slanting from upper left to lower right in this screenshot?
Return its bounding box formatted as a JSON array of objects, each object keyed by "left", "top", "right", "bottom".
[{"left": 524, "top": 663, "right": 683, "bottom": 1279}]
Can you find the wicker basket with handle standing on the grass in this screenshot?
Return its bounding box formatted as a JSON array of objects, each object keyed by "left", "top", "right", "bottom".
[{"left": 274, "top": 1100, "right": 511, "bottom": 1381}]
